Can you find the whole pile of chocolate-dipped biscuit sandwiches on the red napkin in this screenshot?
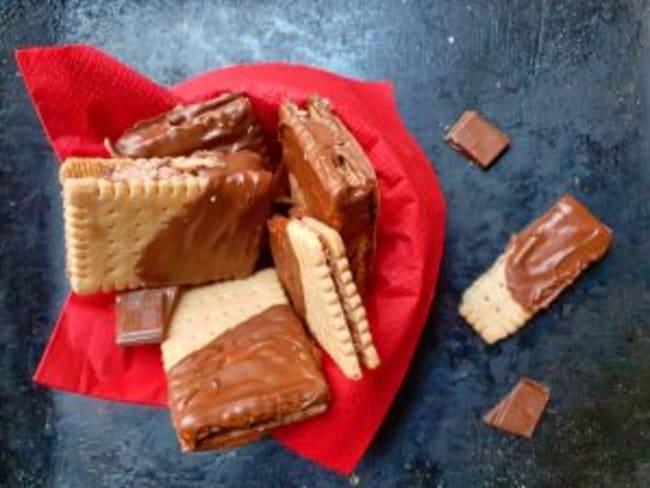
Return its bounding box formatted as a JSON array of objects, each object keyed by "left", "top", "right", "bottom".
[{"left": 60, "top": 93, "right": 380, "bottom": 451}]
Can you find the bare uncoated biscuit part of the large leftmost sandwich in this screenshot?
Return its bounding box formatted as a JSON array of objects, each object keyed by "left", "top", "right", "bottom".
[{"left": 60, "top": 159, "right": 208, "bottom": 294}]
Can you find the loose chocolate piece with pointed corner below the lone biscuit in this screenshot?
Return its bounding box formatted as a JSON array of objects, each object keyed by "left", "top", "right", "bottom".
[{"left": 483, "top": 378, "right": 550, "bottom": 438}]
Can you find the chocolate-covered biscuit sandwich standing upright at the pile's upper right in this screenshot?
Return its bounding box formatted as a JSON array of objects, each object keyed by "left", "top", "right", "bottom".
[{"left": 279, "top": 96, "right": 379, "bottom": 295}]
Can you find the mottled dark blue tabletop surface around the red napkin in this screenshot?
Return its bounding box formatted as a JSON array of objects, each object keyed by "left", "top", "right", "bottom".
[{"left": 0, "top": 0, "right": 650, "bottom": 488}]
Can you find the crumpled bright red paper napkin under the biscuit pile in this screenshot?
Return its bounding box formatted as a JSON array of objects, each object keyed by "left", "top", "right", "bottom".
[{"left": 16, "top": 45, "right": 445, "bottom": 473}]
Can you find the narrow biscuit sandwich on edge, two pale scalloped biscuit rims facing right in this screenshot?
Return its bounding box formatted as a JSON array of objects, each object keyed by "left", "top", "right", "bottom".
[{"left": 268, "top": 216, "right": 380, "bottom": 379}]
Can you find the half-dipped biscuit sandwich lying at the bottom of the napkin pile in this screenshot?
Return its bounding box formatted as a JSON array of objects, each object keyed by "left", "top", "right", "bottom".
[{"left": 162, "top": 269, "right": 329, "bottom": 451}]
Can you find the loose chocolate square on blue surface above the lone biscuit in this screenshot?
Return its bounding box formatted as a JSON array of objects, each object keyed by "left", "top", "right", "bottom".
[{"left": 445, "top": 110, "right": 510, "bottom": 169}]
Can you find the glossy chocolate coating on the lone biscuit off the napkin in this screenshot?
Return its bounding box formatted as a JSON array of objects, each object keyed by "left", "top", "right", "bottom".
[{"left": 505, "top": 195, "right": 612, "bottom": 312}]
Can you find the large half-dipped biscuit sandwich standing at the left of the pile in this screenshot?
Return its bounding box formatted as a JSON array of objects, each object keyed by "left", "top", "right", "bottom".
[{"left": 60, "top": 151, "right": 272, "bottom": 294}]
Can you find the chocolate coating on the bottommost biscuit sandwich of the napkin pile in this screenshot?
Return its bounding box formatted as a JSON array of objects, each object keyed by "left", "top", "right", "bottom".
[{"left": 167, "top": 304, "right": 328, "bottom": 451}]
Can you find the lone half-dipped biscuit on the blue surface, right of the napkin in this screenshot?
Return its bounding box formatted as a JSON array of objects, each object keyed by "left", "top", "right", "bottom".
[{"left": 459, "top": 195, "right": 612, "bottom": 344}]
